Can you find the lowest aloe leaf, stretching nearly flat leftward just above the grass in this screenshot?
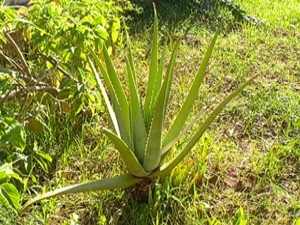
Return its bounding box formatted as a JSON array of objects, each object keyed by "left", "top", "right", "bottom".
[{"left": 22, "top": 173, "right": 143, "bottom": 210}]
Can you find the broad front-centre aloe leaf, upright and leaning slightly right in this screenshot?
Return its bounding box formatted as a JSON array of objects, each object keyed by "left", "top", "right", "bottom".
[{"left": 143, "top": 42, "right": 179, "bottom": 171}]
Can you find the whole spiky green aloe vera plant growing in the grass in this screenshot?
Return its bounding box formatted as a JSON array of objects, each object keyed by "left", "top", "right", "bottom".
[{"left": 24, "top": 9, "right": 255, "bottom": 208}]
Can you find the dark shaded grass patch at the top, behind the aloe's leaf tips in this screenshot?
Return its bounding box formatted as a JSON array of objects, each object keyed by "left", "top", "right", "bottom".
[{"left": 125, "top": 0, "right": 257, "bottom": 37}]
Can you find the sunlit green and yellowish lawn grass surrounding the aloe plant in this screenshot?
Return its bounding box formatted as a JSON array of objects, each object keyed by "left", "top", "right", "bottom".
[{"left": 0, "top": 0, "right": 300, "bottom": 225}]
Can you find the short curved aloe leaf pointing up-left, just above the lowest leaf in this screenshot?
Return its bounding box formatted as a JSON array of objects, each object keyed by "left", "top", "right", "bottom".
[{"left": 103, "top": 129, "right": 149, "bottom": 177}]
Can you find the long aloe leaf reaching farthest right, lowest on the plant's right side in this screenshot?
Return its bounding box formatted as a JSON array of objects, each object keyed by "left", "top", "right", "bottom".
[{"left": 151, "top": 76, "right": 257, "bottom": 177}]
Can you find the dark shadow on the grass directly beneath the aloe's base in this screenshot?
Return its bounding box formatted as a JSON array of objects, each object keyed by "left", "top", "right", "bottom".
[{"left": 80, "top": 184, "right": 187, "bottom": 225}]
